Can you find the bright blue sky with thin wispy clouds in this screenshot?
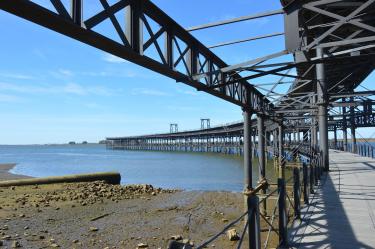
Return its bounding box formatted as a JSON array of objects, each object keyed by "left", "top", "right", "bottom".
[{"left": 0, "top": 0, "right": 374, "bottom": 144}]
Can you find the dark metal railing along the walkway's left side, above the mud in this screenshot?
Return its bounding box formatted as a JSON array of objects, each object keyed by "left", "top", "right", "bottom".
[{"left": 171, "top": 143, "right": 323, "bottom": 249}]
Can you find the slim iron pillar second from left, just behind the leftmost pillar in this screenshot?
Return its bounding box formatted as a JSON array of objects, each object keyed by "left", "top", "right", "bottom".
[{"left": 257, "top": 114, "right": 267, "bottom": 215}]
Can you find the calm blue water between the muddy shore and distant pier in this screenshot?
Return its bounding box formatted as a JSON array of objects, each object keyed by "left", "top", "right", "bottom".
[{"left": 0, "top": 145, "right": 280, "bottom": 191}]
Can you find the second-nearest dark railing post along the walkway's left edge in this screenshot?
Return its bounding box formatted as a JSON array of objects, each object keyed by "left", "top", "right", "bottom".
[{"left": 277, "top": 178, "right": 288, "bottom": 247}]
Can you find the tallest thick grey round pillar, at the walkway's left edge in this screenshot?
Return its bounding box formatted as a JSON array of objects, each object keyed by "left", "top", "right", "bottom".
[{"left": 316, "top": 48, "right": 329, "bottom": 171}]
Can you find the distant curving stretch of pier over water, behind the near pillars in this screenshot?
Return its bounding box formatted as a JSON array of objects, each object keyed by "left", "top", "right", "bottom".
[{"left": 106, "top": 100, "right": 375, "bottom": 156}]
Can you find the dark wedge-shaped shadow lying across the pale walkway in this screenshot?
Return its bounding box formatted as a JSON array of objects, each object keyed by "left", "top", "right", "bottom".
[{"left": 291, "top": 171, "right": 375, "bottom": 249}]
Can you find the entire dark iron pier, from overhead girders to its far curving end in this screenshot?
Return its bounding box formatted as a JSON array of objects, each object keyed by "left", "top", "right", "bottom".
[{"left": 0, "top": 0, "right": 375, "bottom": 249}]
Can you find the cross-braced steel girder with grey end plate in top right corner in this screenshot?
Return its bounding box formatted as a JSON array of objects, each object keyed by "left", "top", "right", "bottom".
[{"left": 284, "top": 0, "right": 375, "bottom": 53}]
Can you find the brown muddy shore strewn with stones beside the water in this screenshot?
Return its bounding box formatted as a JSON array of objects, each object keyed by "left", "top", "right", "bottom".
[{"left": 0, "top": 164, "right": 280, "bottom": 249}]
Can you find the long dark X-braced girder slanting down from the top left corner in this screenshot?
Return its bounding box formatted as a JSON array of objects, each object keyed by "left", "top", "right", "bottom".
[{"left": 0, "top": 0, "right": 273, "bottom": 113}]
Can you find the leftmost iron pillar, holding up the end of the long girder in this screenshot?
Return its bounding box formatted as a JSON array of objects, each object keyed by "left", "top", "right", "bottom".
[{"left": 243, "top": 110, "right": 260, "bottom": 249}]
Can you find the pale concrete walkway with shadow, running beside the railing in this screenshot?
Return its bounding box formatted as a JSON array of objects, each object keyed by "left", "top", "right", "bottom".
[{"left": 290, "top": 150, "right": 375, "bottom": 249}]
